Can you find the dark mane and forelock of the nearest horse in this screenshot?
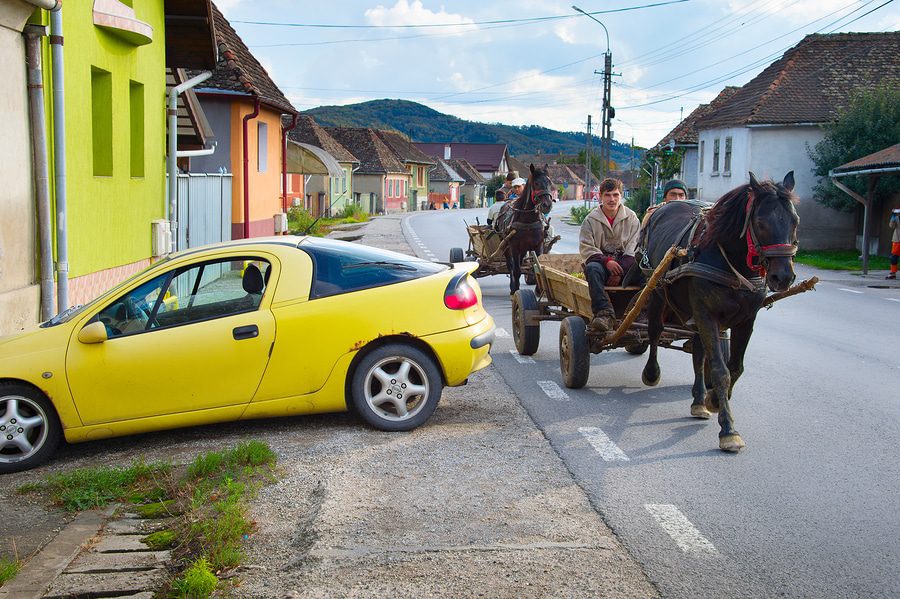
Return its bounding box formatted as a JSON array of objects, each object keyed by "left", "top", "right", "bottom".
[{"left": 697, "top": 181, "right": 800, "bottom": 249}]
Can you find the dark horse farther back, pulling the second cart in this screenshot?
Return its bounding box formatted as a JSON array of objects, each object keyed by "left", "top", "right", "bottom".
[{"left": 497, "top": 164, "right": 553, "bottom": 295}]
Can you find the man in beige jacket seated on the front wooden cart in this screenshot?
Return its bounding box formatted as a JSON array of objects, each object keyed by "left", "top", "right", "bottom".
[{"left": 578, "top": 178, "right": 641, "bottom": 333}]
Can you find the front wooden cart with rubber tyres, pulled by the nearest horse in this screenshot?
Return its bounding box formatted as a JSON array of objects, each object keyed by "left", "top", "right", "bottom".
[{"left": 512, "top": 247, "right": 818, "bottom": 389}]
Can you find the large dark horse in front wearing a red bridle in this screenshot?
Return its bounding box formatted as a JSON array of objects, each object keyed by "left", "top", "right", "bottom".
[{"left": 641, "top": 171, "right": 800, "bottom": 452}]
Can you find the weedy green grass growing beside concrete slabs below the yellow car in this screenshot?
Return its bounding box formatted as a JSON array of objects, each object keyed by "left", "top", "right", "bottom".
[{"left": 20, "top": 441, "right": 276, "bottom": 598}]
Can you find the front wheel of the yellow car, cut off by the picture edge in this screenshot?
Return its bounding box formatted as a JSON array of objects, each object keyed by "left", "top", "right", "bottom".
[{"left": 0, "top": 383, "right": 62, "bottom": 474}]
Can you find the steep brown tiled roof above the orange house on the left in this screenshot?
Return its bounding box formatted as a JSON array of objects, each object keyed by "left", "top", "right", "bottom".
[{"left": 193, "top": 4, "right": 298, "bottom": 114}]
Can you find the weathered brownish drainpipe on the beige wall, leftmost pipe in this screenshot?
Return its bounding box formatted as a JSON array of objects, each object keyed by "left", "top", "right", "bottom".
[{"left": 25, "top": 25, "right": 56, "bottom": 321}]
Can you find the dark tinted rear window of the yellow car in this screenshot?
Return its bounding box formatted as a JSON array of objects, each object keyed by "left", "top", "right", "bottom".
[{"left": 299, "top": 239, "right": 448, "bottom": 297}]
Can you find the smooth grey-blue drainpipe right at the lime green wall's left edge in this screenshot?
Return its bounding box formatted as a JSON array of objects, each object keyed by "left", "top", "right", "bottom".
[{"left": 50, "top": 3, "right": 69, "bottom": 312}]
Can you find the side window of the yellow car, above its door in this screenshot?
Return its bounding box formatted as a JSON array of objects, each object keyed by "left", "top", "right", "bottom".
[{"left": 98, "top": 258, "right": 271, "bottom": 338}]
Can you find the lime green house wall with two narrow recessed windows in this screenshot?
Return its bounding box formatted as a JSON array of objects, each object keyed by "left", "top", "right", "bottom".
[{"left": 44, "top": 0, "right": 166, "bottom": 284}]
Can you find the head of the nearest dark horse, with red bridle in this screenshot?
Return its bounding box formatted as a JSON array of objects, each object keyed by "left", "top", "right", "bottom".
[{"left": 742, "top": 171, "right": 800, "bottom": 291}]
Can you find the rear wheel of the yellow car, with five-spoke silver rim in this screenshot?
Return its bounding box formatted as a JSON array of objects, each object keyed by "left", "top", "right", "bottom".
[{"left": 350, "top": 343, "right": 443, "bottom": 431}]
